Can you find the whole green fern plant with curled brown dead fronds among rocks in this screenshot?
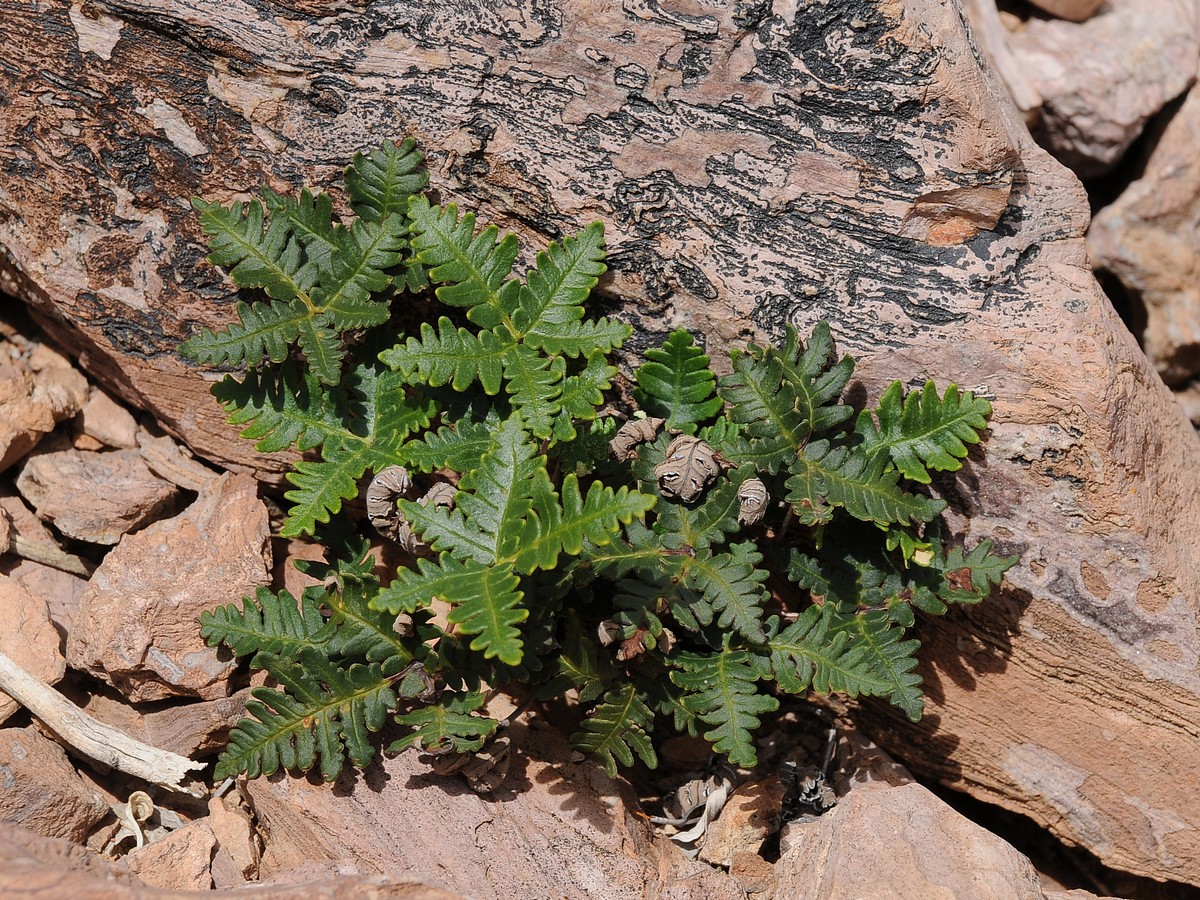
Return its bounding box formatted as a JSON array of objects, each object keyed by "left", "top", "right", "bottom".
[{"left": 181, "top": 140, "right": 1015, "bottom": 790}]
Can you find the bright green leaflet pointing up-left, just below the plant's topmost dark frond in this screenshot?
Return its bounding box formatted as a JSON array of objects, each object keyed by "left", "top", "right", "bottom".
[{"left": 408, "top": 196, "right": 521, "bottom": 328}]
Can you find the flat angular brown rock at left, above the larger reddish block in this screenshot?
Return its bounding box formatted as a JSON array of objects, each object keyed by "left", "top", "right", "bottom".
[{"left": 17, "top": 450, "right": 178, "bottom": 545}]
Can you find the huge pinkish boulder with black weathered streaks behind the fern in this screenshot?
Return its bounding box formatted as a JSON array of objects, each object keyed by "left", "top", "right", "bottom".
[{"left": 0, "top": 0, "right": 1200, "bottom": 883}]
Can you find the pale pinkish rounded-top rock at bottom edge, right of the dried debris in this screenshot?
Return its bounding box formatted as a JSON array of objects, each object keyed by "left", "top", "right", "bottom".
[{"left": 775, "top": 781, "right": 1044, "bottom": 900}]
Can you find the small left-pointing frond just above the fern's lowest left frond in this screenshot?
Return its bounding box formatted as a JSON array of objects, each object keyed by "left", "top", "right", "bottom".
[{"left": 200, "top": 587, "right": 334, "bottom": 658}]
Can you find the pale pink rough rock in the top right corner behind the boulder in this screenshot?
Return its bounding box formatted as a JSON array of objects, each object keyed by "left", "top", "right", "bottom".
[{"left": 1010, "top": 0, "right": 1200, "bottom": 178}]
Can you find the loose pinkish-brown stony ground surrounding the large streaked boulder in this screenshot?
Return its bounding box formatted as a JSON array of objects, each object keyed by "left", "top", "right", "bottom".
[{"left": 7, "top": 0, "right": 1200, "bottom": 900}]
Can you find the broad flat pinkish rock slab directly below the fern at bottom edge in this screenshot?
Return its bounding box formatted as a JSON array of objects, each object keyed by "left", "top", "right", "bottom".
[{"left": 246, "top": 722, "right": 744, "bottom": 900}]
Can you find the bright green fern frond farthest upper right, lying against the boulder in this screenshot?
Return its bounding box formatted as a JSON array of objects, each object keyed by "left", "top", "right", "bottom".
[{"left": 857, "top": 382, "right": 991, "bottom": 485}]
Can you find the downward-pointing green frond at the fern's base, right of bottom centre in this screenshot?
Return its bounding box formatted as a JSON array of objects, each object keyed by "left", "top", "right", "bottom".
[{"left": 671, "top": 646, "right": 779, "bottom": 769}]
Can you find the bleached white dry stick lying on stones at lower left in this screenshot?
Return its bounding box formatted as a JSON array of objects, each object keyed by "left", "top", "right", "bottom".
[{"left": 0, "top": 653, "right": 204, "bottom": 797}]
